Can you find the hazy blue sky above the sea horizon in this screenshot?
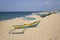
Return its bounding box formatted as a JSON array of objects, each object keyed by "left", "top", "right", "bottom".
[{"left": 0, "top": 0, "right": 60, "bottom": 12}]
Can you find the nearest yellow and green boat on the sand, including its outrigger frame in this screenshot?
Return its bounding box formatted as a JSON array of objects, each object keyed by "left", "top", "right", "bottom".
[{"left": 9, "top": 21, "right": 40, "bottom": 34}]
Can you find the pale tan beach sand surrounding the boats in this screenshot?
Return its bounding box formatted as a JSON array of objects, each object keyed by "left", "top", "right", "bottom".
[{"left": 0, "top": 14, "right": 60, "bottom": 40}]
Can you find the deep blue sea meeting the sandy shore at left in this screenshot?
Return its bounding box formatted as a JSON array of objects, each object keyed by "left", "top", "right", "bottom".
[{"left": 0, "top": 11, "right": 42, "bottom": 21}]
